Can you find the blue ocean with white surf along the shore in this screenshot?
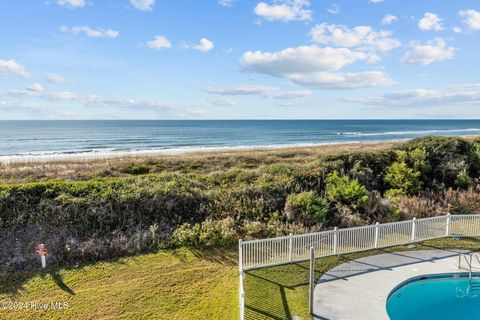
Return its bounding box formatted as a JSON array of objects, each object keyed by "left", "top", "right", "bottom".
[{"left": 0, "top": 120, "right": 480, "bottom": 158}]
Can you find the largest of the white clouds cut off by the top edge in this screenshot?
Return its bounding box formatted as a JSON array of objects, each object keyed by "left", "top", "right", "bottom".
[{"left": 254, "top": 0, "right": 312, "bottom": 22}]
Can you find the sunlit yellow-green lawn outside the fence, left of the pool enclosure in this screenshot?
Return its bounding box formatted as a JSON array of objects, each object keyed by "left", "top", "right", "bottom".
[{"left": 0, "top": 249, "right": 238, "bottom": 320}]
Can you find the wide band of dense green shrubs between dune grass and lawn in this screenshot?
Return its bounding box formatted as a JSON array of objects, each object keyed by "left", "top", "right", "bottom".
[{"left": 0, "top": 137, "right": 480, "bottom": 272}]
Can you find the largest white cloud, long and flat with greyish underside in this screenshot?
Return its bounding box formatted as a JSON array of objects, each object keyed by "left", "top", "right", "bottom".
[{"left": 240, "top": 45, "right": 393, "bottom": 89}]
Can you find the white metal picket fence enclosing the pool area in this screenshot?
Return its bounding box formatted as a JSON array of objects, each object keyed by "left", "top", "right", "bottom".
[{"left": 239, "top": 214, "right": 480, "bottom": 320}]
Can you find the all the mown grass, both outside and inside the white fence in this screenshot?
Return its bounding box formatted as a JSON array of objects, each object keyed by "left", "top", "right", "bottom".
[{"left": 0, "top": 239, "right": 480, "bottom": 320}]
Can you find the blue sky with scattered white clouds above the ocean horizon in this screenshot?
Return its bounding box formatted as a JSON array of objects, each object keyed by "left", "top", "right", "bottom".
[{"left": 0, "top": 0, "right": 480, "bottom": 120}]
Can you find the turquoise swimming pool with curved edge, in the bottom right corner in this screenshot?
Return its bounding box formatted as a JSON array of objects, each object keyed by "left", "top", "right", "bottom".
[{"left": 387, "top": 274, "right": 480, "bottom": 320}]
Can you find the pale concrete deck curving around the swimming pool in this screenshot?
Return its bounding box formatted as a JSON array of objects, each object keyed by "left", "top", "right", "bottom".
[{"left": 313, "top": 250, "right": 480, "bottom": 320}]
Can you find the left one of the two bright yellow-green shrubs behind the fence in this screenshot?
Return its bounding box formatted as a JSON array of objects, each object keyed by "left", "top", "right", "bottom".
[{"left": 326, "top": 171, "right": 368, "bottom": 207}]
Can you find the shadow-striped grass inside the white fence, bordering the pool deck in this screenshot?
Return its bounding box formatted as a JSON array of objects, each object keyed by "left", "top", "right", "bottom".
[{"left": 244, "top": 238, "right": 480, "bottom": 320}]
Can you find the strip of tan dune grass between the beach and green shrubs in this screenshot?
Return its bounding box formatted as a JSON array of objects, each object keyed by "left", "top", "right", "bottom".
[{"left": 0, "top": 141, "right": 401, "bottom": 184}]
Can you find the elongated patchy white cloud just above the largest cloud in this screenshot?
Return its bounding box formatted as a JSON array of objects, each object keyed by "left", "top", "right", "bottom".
[{"left": 310, "top": 23, "right": 401, "bottom": 52}]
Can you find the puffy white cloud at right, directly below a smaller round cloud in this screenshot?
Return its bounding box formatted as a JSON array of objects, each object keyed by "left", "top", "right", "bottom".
[{"left": 400, "top": 38, "right": 457, "bottom": 65}]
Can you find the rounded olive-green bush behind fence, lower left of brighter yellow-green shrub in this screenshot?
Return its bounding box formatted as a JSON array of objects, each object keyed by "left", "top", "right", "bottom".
[{"left": 285, "top": 191, "right": 330, "bottom": 224}]
